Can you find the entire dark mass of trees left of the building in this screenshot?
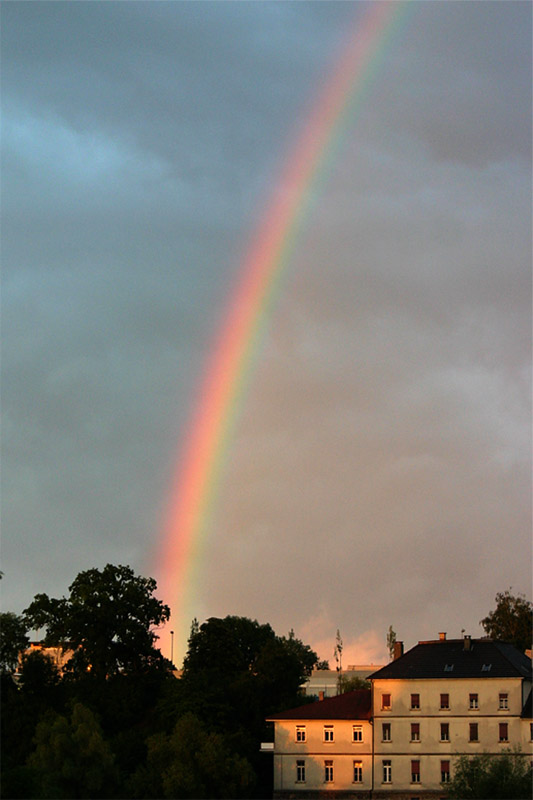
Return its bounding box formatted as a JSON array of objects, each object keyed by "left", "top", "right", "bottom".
[{"left": 0, "top": 565, "right": 317, "bottom": 798}]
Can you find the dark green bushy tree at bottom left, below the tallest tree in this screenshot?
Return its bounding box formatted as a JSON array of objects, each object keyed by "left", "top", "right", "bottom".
[{"left": 28, "top": 703, "right": 116, "bottom": 798}]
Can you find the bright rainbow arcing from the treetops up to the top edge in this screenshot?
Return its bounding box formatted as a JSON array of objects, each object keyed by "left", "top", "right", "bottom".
[{"left": 153, "top": 0, "right": 409, "bottom": 655}]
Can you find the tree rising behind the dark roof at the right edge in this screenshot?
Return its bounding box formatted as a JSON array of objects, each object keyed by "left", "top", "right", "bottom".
[{"left": 480, "top": 589, "right": 533, "bottom": 653}]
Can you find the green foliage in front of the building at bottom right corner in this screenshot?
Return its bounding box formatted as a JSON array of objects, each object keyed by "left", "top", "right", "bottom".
[{"left": 443, "top": 749, "right": 533, "bottom": 800}]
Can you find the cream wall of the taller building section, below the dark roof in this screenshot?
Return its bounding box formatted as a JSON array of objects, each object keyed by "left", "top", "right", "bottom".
[{"left": 373, "top": 678, "right": 531, "bottom": 796}]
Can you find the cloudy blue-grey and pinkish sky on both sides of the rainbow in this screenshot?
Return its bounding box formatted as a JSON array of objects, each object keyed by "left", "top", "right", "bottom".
[{"left": 2, "top": 0, "right": 532, "bottom": 663}]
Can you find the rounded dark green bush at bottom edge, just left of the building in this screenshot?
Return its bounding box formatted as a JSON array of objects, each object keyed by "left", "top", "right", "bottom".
[{"left": 131, "top": 714, "right": 254, "bottom": 798}]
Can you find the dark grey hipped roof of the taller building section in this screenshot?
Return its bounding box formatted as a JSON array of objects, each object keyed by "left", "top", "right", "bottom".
[{"left": 369, "top": 639, "right": 531, "bottom": 680}]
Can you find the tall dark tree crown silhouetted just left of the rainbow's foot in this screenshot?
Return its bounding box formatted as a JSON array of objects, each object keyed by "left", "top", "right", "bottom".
[{"left": 24, "top": 564, "right": 170, "bottom": 677}]
